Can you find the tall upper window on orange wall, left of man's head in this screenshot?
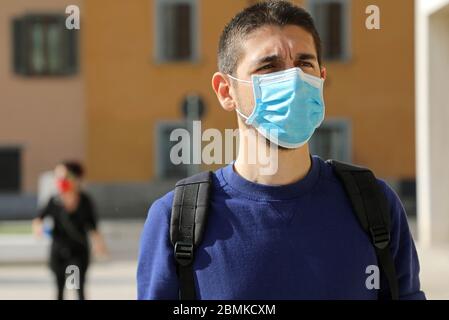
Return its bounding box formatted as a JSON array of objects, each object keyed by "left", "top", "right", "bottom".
[{"left": 156, "top": 0, "right": 196, "bottom": 62}]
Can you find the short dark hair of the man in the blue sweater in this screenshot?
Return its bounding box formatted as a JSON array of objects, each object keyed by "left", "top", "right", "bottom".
[{"left": 218, "top": 0, "right": 321, "bottom": 74}]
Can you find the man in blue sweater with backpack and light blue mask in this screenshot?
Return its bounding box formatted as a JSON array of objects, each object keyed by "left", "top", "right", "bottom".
[{"left": 137, "top": 1, "right": 425, "bottom": 300}]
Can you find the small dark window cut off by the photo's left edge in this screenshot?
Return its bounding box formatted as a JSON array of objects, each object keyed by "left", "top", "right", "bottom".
[{"left": 0, "top": 148, "right": 20, "bottom": 192}]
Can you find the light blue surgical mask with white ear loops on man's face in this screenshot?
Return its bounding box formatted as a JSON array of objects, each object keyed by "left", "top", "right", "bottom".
[{"left": 229, "top": 68, "right": 325, "bottom": 149}]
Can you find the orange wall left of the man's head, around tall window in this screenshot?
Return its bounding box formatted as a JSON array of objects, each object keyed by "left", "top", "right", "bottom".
[{"left": 84, "top": 0, "right": 246, "bottom": 181}]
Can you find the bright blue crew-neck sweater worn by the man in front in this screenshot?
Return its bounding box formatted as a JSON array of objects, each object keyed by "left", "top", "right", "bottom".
[{"left": 137, "top": 156, "right": 425, "bottom": 300}]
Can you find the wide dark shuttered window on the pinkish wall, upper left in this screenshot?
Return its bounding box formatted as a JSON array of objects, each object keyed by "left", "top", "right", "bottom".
[{"left": 13, "top": 15, "right": 77, "bottom": 75}]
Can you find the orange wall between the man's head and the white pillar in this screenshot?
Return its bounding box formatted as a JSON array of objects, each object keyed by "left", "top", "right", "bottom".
[{"left": 325, "top": 0, "right": 415, "bottom": 178}]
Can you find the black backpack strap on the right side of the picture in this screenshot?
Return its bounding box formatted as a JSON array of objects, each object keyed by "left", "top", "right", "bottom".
[{"left": 327, "top": 160, "right": 399, "bottom": 300}]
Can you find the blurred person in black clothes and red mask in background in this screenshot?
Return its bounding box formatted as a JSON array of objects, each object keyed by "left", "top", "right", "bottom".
[{"left": 33, "top": 162, "right": 106, "bottom": 300}]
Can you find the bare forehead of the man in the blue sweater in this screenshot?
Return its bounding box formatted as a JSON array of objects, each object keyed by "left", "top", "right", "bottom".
[{"left": 241, "top": 26, "right": 316, "bottom": 63}]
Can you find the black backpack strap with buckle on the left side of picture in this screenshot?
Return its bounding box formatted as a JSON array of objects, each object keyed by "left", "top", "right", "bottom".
[{"left": 170, "top": 172, "right": 212, "bottom": 300}]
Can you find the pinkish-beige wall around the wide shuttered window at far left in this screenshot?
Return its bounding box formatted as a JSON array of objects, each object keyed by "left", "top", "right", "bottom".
[{"left": 0, "top": 0, "right": 85, "bottom": 192}]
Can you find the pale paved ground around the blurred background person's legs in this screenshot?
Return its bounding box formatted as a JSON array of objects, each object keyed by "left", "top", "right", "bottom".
[{"left": 0, "top": 220, "right": 143, "bottom": 300}]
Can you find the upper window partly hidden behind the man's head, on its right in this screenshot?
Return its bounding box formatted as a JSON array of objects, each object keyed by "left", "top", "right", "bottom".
[{"left": 309, "top": 0, "right": 349, "bottom": 60}]
